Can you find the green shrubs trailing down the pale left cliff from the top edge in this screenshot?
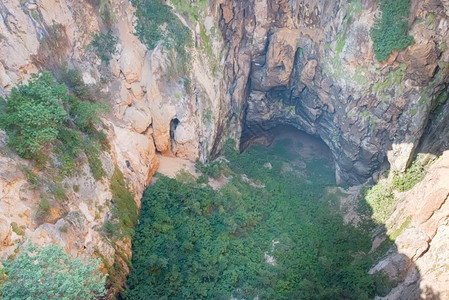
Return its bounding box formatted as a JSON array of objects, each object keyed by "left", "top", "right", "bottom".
[{"left": 131, "top": 0, "right": 193, "bottom": 77}]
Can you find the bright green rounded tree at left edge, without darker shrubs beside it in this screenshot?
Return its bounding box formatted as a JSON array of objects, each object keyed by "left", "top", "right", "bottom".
[{"left": 0, "top": 72, "right": 68, "bottom": 158}]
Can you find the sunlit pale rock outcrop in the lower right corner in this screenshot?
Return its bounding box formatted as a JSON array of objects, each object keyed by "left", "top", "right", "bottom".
[{"left": 372, "top": 151, "right": 449, "bottom": 299}]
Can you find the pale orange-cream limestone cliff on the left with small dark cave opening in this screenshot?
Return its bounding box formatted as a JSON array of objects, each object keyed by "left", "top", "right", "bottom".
[{"left": 0, "top": 0, "right": 226, "bottom": 292}]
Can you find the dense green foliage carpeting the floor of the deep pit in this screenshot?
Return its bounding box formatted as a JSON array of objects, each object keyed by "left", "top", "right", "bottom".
[{"left": 124, "top": 141, "right": 375, "bottom": 299}]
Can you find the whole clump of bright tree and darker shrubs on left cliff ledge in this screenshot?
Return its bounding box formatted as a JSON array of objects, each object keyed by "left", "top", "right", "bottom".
[{"left": 0, "top": 68, "right": 108, "bottom": 178}]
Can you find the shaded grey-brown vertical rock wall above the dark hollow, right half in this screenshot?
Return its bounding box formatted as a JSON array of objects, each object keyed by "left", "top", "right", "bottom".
[{"left": 220, "top": 0, "right": 449, "bottom": 183}]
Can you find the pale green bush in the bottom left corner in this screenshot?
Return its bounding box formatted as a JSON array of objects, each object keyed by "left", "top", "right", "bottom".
[{"left": 1, "top": 244, "right": 105, "bottom": 300}]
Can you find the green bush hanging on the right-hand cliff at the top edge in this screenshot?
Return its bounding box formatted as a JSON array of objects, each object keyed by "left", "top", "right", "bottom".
[{"left": 370, "top": 0, "right": 414, "bottom": 61}]
